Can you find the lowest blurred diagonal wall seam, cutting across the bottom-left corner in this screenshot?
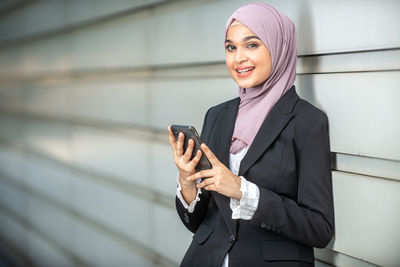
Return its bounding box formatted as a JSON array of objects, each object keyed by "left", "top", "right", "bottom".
[{"left": 0, "top": 203, "right": 94, "bottom": 266}]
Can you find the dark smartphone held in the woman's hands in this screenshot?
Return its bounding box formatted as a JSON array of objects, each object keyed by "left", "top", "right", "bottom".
[{"left": 171, "top": 124, "right": 211, "bottom": 171}]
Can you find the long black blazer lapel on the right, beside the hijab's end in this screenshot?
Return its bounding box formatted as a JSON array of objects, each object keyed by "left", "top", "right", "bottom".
[{"left": 239, "top": 86, "right": 299, "bottom": 176}]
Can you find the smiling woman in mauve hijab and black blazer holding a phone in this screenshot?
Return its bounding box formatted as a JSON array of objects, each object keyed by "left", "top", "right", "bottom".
[{"left": 169, "top": 3, "right": 334, "bottom": 266}]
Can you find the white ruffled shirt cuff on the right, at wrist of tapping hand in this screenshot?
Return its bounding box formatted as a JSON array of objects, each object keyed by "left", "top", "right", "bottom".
[{"left": 230, "top": 176, "right": 260, "bottom": 220}]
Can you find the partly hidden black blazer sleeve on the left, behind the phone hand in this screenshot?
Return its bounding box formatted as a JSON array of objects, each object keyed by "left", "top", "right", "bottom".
[{"left": 175, "top": 108, "right": 212, "bottom": 233}]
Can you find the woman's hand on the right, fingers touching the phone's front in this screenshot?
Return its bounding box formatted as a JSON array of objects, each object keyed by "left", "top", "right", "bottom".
[{"left": 187, "top": 144, "right": 242, "bottom": 200}]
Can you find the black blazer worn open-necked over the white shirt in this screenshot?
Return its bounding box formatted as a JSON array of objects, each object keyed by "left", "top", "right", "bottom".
[{"left": 176, "top": 86, "right": 334, "bottom": 267}]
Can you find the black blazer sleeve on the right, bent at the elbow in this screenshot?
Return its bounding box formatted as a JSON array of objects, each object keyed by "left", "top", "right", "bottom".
[{"left": 250, "top": 114, "right": 334, "bottom": 248}]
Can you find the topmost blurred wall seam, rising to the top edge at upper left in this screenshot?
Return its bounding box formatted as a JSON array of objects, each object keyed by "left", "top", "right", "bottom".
[{"left": 0, "top": 0, "right": 179, "bottom": 51}]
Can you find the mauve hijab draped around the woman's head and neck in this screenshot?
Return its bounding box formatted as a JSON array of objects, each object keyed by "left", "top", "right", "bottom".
[{"left": 225, "top": 2, "right": 297, "bottom": 154}]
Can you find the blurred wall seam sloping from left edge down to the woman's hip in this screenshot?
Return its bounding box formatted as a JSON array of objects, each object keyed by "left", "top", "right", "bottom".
[{"left": 0, "top": 173, "right": 177, "bottom": 266}]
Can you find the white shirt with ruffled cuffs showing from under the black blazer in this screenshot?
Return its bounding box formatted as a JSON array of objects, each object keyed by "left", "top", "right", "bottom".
[{"left": 176, "top": 146, "right": 260, "bottom": 267}]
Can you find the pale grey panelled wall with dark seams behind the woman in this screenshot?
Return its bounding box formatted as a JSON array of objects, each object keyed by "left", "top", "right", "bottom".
[{"left": 0, "top": 0, "right": 400, "bottom": 266}]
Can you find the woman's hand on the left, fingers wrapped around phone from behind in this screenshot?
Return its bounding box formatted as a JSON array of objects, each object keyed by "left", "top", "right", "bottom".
[{"left": 168, "top": 126, "right": 201, "bottom": 191}]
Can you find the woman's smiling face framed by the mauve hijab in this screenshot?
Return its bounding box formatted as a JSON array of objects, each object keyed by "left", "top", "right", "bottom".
[{"left": 225, "top": 21, "right": 271, "bottom": 88}]
